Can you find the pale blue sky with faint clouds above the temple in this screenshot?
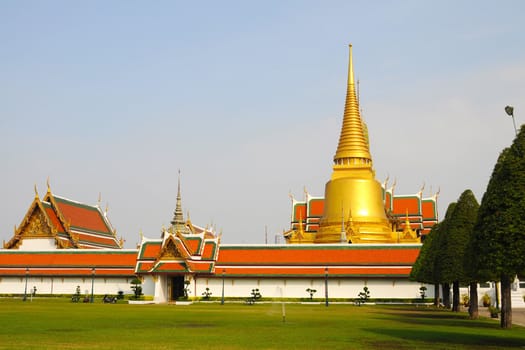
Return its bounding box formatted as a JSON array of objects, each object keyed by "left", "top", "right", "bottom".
[{"left": 0, "top": 1, "right": 525, "bottom": 247}]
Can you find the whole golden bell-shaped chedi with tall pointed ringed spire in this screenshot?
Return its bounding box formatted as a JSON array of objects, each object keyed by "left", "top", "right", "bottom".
[{"left": 314, "top": 45, "right": 419, "bottom": 243}]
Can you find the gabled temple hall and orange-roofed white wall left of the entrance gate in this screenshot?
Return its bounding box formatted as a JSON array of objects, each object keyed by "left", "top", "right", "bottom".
[{"left": 0, "top": 185, "right": 137, "bottom": 295}]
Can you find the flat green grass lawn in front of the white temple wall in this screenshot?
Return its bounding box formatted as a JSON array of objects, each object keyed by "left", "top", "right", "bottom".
[{"left": 0, "top": 298, "right": 525, "bottom": 350}]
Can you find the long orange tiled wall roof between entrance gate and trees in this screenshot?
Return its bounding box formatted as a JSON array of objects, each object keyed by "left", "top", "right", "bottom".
[{"left": 215, "top": 244, "right": 420, "bottom": 277}]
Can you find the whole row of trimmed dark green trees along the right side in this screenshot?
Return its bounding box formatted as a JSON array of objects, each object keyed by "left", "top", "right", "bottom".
[{"left": 411, "top": 125, "right": 525, "bottom": 328}]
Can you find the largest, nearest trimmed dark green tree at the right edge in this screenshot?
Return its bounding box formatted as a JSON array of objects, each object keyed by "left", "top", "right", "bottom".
[{"left": 472, "top": 125, "right": 525, "bottom": 328}]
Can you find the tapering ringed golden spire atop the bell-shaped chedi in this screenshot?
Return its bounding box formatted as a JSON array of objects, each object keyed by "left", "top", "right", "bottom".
[{"left": 334, "top": 45, "right": 372, "bottom": 167}]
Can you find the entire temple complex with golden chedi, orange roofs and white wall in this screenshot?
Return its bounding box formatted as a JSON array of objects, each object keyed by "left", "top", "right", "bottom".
[{"left": 4, "top": 47, "right": 494, "bottom": 303}]
